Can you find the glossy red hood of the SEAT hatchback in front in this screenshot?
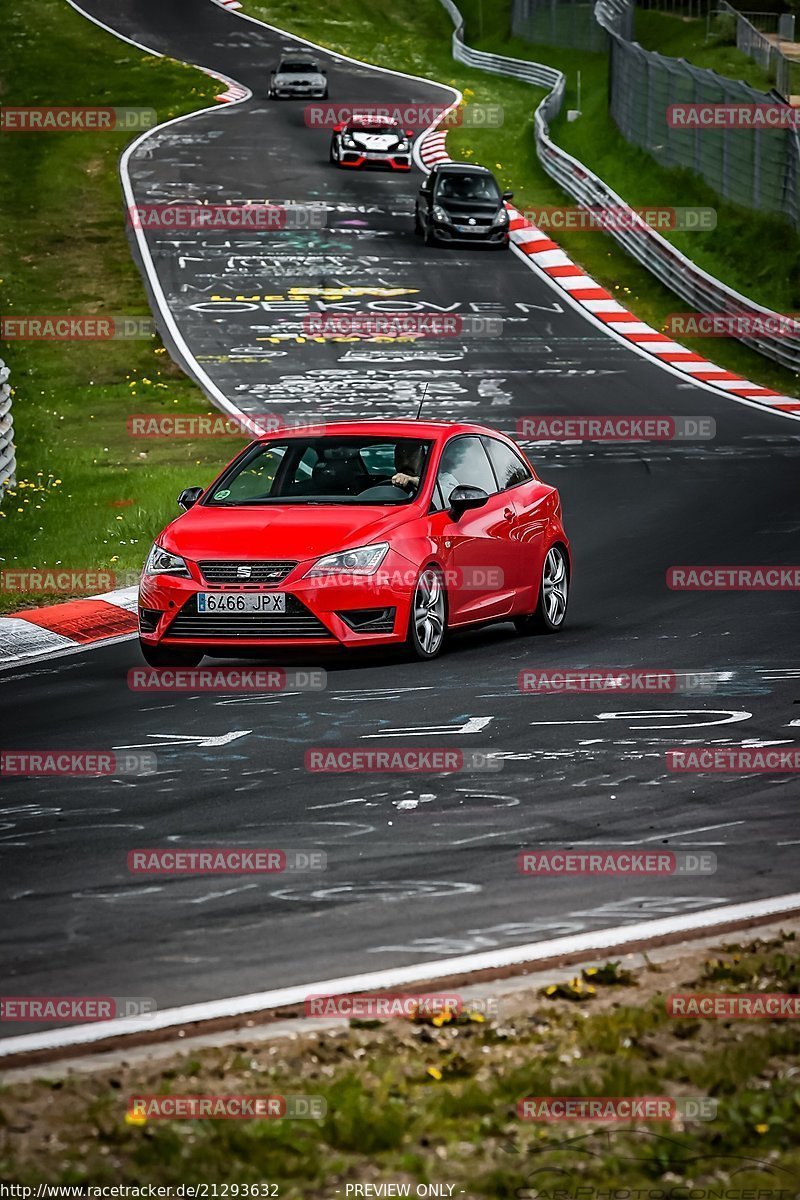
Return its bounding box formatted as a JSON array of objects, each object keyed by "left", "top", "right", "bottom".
[{"left": 158, "top": 504, "right": 419, "bottom": 562}]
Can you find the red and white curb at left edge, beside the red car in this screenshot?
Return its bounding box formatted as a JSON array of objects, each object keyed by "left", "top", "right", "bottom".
[{"left": 0, "top": 587, "right": 138, "bottom": 667}]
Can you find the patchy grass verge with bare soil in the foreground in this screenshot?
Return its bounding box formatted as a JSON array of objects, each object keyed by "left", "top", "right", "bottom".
[{"left": 0, "top": 932, "right": 800, "bottom": 1200}]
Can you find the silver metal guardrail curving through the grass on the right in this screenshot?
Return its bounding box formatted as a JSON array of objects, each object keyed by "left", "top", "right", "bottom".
[{"left": 441, "top": 0, "right": 800, "bottom": 371}]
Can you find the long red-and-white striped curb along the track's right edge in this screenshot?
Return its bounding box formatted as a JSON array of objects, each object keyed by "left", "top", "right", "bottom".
[{"left": 417, "top": 130, "right": 800, "bottom": 416}]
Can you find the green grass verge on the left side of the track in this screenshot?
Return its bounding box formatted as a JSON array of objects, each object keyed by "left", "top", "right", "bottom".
[{"left": 0, "top": 0, "right": 237, "bottom": 612}]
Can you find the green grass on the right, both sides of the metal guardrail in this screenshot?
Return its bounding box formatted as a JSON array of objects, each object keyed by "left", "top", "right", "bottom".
[{"left": 245, "top": 0, "right": 800, "bottom": 395}]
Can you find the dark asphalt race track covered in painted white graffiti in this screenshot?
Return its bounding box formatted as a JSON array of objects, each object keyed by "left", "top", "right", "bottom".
[{"left": 0, "top": 0, "right": 800, "bottom": 1032}]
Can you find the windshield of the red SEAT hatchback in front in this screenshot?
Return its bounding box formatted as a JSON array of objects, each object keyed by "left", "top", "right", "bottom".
[{"left": 204, "top": 436, "right": 431, "bottom": 506}]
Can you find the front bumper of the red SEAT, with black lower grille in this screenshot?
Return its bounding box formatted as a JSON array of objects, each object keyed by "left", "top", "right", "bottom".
[{"left": 139, "top": 551, "right": 416, "bottom": 652}]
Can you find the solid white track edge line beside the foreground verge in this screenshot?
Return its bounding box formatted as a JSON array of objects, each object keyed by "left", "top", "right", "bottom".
[{"left": 0, "top": 892, "right": 800, "bottom": 1057}]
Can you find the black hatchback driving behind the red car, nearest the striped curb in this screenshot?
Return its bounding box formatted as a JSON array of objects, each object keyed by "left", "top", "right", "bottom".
[{"left": 414, "top": 162, "right": 513, "bottom": 247}]
